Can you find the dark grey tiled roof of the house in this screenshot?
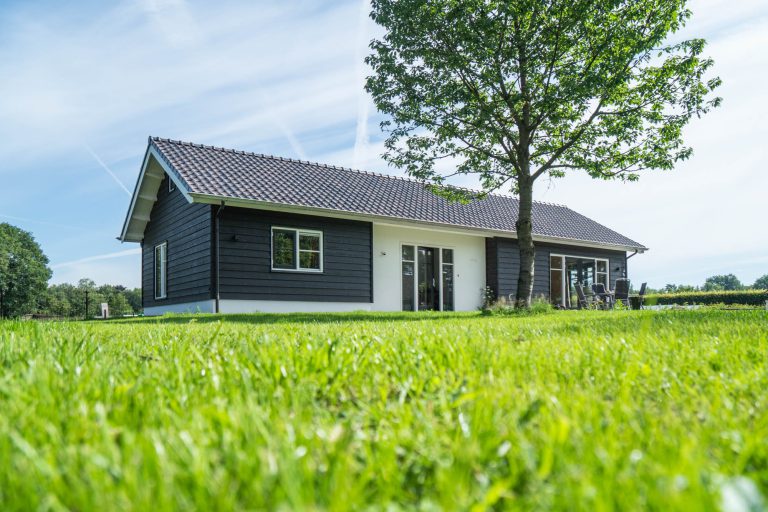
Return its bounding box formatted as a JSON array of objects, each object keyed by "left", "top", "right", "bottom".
[{"left": 149, "top": 137, "right": 645, "bottom": 249}]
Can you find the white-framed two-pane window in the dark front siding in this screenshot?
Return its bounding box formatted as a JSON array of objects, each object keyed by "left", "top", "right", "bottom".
[{"left": 272, "top": 228, "right": 323, "bottom": 272}]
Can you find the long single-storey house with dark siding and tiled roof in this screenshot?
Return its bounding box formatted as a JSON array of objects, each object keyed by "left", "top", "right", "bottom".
[{"left": 119, "top": 137, "right": 647, "bottom": 315}]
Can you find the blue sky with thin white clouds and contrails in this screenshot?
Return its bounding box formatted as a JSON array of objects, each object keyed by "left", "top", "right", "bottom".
[{"left": 0, "top": 0, "right": 768, "bottom": 287}]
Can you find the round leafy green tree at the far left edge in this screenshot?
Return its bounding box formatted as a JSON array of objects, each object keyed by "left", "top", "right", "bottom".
[{"left": 0, "top": 223, "right": 51, "bottom": 317}]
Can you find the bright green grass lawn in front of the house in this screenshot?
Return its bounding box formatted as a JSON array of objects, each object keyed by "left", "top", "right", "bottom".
[{"left": 0, "top": 311, "right": 768, "bottom": 512}]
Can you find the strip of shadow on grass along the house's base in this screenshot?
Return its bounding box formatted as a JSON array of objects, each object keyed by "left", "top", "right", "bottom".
[{"left": 101, "top": 311, "right": 481, "bottom": 324}]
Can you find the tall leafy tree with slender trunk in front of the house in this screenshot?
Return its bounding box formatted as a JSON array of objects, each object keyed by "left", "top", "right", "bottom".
[{"left": 366, "top": 0, "right": 720, "bottom": 307}]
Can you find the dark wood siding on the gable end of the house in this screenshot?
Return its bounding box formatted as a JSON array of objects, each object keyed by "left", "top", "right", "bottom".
[{"left": 141, "top": 176, "right": 212, "bottom": 307}]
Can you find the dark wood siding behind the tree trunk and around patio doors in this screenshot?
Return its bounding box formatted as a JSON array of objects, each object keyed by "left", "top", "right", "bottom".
[{"left": 486, "top": 237, "right": 627, "bottom": 299}]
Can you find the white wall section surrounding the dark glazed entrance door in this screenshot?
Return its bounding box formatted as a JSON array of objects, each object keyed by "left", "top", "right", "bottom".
[{"left": 372, "top": 224, "right": 485, "bottom": 311}]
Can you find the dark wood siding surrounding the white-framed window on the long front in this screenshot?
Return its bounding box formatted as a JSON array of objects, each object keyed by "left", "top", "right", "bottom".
[{"left": 219, "top": 207, "right": 373, "bottom": 302}]
